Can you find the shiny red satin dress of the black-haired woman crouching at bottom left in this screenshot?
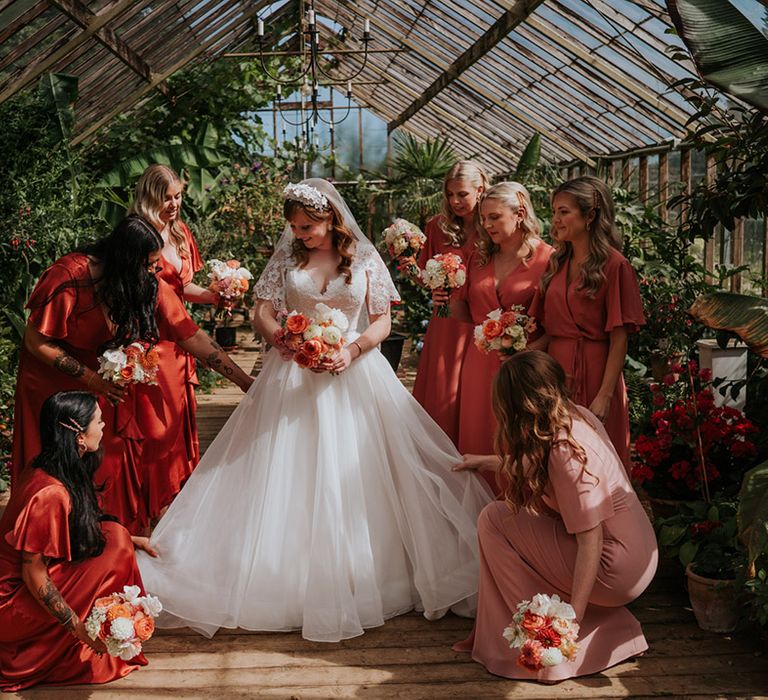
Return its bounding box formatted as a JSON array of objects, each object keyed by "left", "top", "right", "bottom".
[{"left": 0, "top": 469, "right": 147, "bottom": 692}]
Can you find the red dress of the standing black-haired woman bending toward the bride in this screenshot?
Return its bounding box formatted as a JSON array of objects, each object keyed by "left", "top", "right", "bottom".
[{"left": 11, "top": 253, "right": 198, "bottom": 533}]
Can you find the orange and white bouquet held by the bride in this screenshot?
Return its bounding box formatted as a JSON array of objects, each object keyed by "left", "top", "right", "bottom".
[{"left": 275, "top": 304, "right": 349, "bottom": 369}]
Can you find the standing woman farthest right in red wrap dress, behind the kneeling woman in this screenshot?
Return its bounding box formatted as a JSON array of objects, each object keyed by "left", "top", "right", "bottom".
[{"left": 535, "top": 175, "right": 645, "bottom": 469}]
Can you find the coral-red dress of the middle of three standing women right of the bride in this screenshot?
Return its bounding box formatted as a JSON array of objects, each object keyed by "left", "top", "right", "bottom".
[{"left": 458, "top": 241, "right": 552, "bottom": 496}]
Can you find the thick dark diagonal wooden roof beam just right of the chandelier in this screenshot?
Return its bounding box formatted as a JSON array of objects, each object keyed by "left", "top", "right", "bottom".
[{"left": 387, "top": 0, "right": 544, "bottom": 132}]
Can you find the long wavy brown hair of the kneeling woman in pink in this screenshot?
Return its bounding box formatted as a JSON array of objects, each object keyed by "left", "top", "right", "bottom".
[{"left": 493, "top": 350, "right": 597, "bottom": 513}]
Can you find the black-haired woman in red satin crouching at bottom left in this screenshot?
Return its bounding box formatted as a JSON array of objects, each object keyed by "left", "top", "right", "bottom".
[{"left": 0, "top": 391, "right": 154, "bottom": 691}]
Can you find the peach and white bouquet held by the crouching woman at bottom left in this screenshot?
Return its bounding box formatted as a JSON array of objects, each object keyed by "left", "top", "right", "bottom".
[{"left": 85, "top": 586, "right": 163, "bottom": 661}]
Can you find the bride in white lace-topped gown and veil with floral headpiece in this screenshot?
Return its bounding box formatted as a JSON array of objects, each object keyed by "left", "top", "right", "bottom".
[{"left": 138, "top": 178, "right": 492, "bottom": 642}]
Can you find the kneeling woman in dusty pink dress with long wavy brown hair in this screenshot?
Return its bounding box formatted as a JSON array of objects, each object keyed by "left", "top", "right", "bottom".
[{"left": 454, "top": 351, "right": 658, "bottom": 682}]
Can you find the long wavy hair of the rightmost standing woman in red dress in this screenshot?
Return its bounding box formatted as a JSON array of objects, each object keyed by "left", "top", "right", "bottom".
[{"left": 541, "top": 175, "right": 622, "bottom": 297}]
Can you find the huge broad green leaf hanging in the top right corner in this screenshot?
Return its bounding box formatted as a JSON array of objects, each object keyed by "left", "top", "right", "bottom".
[{"left": 667, "top": 0, "right": 768, "bottom": 111}]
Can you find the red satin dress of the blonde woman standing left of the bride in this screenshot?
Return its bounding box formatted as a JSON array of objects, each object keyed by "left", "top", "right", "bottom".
[{"left": 136, "top": 224, "right": 203, "bottom": 519}]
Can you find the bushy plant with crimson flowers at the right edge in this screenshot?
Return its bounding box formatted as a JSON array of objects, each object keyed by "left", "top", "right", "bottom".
[{"left": 632, "top": 361, "right": 758, "bottom": 508}]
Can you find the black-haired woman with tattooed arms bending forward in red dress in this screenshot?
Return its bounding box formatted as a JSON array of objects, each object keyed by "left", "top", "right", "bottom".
[{"left": 11, "top": 217, "right": 253, "bottom": 532}]
